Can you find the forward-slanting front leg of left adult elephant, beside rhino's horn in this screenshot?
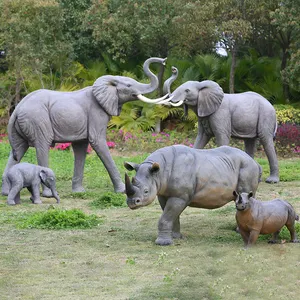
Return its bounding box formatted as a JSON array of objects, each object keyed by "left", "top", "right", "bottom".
[{"left": 90, "top": 139, "right": 125, "bottom": 193}]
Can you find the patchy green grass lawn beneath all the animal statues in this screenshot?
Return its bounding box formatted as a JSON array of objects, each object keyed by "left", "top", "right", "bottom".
[{"left": 0, "top": 143, "right": 300, "bottom": 300}]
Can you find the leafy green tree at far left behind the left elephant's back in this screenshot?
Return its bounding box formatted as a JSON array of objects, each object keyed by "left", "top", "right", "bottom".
[{"left": 0, "top": 0, "right": 72, "bottom": 105}]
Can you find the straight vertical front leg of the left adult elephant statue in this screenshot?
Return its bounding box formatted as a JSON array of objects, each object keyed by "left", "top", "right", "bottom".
[{"left": 72, "top": 141, "right": 89, "bottom": 193}]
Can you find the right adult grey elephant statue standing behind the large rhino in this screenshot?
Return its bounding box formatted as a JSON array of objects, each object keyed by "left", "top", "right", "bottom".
[{"left": 166, "top": 80, "right": 279, "bottom": 183}]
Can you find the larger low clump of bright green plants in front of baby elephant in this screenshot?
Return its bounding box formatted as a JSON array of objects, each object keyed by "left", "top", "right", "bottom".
[{"left": 19, "top": 208, "right": 103, "bottom": 230}]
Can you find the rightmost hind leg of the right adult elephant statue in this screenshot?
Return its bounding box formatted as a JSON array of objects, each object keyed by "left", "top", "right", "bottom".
[{"left": 261, "top": 137, "right": 279, "bottom": 183}]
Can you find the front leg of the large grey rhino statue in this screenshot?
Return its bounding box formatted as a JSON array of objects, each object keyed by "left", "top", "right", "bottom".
[{"left": 155, "top": 197, "right": 187, "bottom": 246}]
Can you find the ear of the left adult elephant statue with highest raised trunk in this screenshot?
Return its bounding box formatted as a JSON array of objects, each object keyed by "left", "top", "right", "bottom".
[{"left": 93, "top": 76, "right": 120, "bottom": 116}]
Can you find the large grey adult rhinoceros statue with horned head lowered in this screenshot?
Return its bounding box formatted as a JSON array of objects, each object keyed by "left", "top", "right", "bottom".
[{"left": 124, "top": 145, "right": 261, "bottom": 245}]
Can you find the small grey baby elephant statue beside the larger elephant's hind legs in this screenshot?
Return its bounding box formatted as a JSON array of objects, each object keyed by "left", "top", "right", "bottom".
[{"left": 7, "top": 162, "right": 60, "bottom": 205}]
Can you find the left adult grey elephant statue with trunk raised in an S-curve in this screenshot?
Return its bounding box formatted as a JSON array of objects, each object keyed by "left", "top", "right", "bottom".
[{"left": 2, "top": 57, "right": 166, "bottom": 197}]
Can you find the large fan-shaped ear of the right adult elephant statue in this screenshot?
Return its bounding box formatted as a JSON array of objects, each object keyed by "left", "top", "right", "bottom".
[{"left": 197, "top": 80, "right": 224, "bottom": 117}]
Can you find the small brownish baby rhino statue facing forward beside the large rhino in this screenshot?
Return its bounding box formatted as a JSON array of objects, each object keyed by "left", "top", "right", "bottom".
[{"left": 233, "top": 191, "right": 299, "bottom": 248}]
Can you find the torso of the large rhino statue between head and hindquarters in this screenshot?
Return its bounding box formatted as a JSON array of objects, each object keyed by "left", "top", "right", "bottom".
[{"left": 147, "top": 145, "right": 250, "bottom": 208}]
